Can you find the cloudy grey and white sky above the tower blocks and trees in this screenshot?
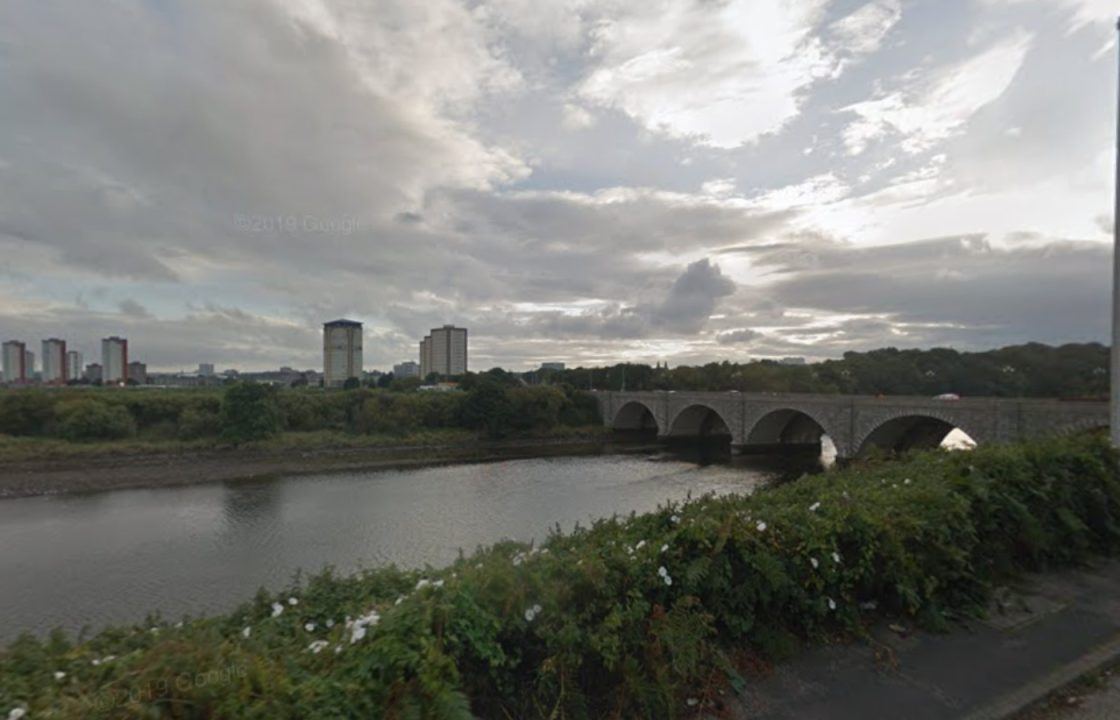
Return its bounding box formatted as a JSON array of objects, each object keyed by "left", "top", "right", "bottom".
[{"left": 0, "top": 0, "right": 1120, "bottom": 371}]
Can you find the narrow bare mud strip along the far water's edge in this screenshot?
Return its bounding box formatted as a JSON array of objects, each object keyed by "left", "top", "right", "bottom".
[{"left": 0, "top": 437, "right": 647, "bottom": 502}]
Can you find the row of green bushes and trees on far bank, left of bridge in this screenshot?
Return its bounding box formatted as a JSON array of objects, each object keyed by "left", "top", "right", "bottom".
[{"left": 0, "top": 373, "right": 600, "bottom": 443}]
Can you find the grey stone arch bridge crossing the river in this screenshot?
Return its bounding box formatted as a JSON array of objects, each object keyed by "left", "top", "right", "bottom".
[{"left": 595, "top": 391, "right": 1109, "bottom": 458}]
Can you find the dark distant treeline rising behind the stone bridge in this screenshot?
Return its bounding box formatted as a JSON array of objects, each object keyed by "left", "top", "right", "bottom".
[{"left": 533, "top": 343, "right": 1109, "bottom": 399}]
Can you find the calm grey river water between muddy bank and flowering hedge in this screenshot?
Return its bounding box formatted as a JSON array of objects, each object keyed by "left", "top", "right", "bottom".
[{"left": 0, "top": 455, "right": 788, "bottom": 644}]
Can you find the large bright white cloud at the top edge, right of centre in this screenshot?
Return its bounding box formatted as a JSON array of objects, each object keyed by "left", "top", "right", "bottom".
[{"left": 580, "top": 0, "right": 833, "bottom": 148}]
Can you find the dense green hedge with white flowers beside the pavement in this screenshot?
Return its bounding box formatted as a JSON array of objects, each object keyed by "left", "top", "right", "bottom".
[{"left": 0, "top": 438, "right": 1120, "bottom": 720}]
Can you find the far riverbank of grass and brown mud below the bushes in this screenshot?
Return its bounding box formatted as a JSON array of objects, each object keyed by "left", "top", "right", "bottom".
[{"left": 0, "top": 428, "right": 610, "bottom": 499}]
